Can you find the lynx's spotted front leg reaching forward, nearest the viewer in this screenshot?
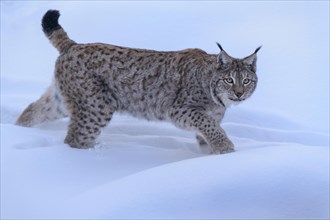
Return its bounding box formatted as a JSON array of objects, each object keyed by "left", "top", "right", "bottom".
[{"left": 170, "top": 108, "right": 234, "bottom": 154}]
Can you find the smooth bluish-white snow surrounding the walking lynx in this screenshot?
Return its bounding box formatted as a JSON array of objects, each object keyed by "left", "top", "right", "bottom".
[{"left": 0, "top": 1, "right": 330, "bottom": 219}]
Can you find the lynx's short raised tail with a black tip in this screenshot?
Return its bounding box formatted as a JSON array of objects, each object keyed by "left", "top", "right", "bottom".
[{"left": 41, "top": 10, "right": 76, "bottom": 53}]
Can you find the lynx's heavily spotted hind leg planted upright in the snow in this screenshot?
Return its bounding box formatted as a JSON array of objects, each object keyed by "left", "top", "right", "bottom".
[{"left": 64, "top": 91, "right": 115, "bottom": 149}]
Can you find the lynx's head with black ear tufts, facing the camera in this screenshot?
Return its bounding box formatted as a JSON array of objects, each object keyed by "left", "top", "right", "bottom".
[{"left": 210, "top": 43, "right": 261, "bottom": 106}]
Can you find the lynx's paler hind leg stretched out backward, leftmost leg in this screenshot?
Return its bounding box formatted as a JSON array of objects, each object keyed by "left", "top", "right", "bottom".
[{"left": 16, "top": 84, "right": 68, "bottom": 127}]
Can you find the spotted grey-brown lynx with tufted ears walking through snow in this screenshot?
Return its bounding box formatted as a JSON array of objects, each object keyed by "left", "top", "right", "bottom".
[{"left": 17, "top": 10, "right": 261, "bottom": 154}]
